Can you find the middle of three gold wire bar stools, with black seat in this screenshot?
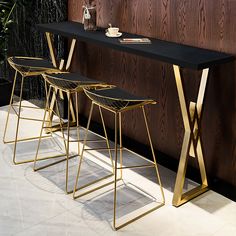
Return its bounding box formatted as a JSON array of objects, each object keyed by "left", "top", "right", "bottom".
[{"left": 33, "top": 73, "right": 113, "bottom": 194}]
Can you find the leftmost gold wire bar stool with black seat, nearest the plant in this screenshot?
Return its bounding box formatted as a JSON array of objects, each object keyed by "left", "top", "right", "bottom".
[{"left": 3, "top": 57, "right": 59, "bottom": 165}]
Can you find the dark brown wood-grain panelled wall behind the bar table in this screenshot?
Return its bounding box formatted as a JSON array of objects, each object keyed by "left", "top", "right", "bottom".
[{"left": 68, "top": 0, "right": 236, "bottom": 186}]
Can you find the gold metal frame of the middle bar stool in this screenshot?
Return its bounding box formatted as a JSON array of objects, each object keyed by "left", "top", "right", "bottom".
[{"left": 33, "top": 72, "right": 114, "bottom": 194}]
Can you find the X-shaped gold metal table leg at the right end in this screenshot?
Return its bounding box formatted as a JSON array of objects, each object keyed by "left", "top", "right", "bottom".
[{"left": 172, "top": 65, "right": 209, "bottom": 207}]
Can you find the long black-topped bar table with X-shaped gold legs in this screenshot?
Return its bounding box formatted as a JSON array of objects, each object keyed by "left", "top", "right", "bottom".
[{"left": 38, "top": 21, "right": 234, "bottom": 207}]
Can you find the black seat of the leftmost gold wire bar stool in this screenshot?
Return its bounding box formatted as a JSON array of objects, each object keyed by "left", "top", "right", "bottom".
[{"left": 8, "top": 57, "right": 59, "bottom": 75}]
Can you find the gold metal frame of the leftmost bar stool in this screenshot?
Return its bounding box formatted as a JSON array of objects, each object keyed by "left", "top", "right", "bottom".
[{"left": 3, "top": 57, "right": 58, "bottom": 165}]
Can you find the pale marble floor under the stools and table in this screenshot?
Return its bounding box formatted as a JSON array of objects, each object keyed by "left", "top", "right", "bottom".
[{"left": 0, "top": 102, "right": 236, "bottom": 236}]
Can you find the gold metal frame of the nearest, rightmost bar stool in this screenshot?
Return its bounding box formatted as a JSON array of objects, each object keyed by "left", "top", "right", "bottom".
[{"left": 73, "top": 94, "right": 165, "bottom": 230}]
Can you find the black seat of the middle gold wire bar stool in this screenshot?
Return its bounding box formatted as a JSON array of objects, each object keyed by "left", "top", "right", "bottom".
[{"left": 44, "top": 73, "right": 104, "bottom": 91}]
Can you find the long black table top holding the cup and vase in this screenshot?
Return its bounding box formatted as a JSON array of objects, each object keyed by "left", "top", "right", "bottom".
[{"left": 38, "top": 21, "right": 234, "bottom": 69}]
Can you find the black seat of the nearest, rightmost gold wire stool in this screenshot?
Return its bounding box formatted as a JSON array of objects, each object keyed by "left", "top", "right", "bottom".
[{"left": 85, "top": 87, "right": 156, "bottom": 111}]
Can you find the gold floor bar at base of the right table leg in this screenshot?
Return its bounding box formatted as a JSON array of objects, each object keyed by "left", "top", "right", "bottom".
[{"left": 172, "top": 185, "right": 209, "bottom": 207}]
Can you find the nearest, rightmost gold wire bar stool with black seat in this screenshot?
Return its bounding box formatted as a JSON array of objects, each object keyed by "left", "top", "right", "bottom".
[{"left": 73, "top": 87, "right": 165, "bottom": 230}]
